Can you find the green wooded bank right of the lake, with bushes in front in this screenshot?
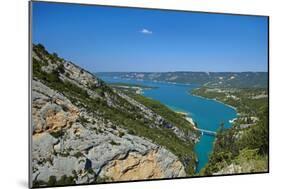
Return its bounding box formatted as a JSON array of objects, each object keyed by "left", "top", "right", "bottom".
[{"left": 193, "top": 87, "right": 269, "bottom": 175}]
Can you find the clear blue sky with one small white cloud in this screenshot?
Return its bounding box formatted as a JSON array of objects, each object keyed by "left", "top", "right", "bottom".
[{"left": 32, "top": 2, "right": 268, "bottom": 72}]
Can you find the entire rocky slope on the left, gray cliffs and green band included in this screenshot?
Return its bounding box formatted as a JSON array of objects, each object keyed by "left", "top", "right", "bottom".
[{"left": 31, "top": 45, "right": 197, "bottom": 187}]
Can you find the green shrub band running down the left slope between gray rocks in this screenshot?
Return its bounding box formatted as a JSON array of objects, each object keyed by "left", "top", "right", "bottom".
[{"left": 33, "top": 43, "right": 196, "bottom": 175}]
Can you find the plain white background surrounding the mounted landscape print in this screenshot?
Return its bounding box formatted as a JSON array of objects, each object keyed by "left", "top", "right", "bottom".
[{"left": 0, "top": 0, "right": 281, "bottom": 189}]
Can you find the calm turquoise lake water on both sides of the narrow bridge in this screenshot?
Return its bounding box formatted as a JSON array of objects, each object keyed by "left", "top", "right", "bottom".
[{"left": 101, "top": 77, "right": 236, "bottom": 172}]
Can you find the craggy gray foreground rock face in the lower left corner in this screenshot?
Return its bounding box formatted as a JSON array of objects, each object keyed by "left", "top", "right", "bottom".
[{"left": 32, "top": 80, "right": 186, "bottom": 184}]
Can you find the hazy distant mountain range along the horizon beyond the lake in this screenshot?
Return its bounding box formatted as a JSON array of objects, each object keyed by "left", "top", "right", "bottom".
[{"left": 96, "top": 72, "right": 268, "bottom": 88}]
